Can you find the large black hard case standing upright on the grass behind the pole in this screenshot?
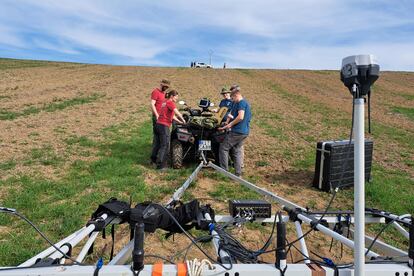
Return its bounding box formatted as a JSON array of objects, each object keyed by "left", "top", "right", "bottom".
[{"left": 313, "top": 139, "right": 374, "bottom": 192}]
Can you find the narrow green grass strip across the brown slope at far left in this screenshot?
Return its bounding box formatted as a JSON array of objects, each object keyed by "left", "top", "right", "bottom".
[{"left": 0, "top": 93, "right": 105, "bottom": 120}]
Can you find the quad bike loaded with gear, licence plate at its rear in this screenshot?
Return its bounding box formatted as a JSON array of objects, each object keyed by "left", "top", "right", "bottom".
[{"left": 171, "top": 98, "right": 227, "bottom": 169}]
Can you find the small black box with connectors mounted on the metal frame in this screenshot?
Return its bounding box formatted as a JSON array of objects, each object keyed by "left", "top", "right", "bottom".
[{"left": 229, "top": 200, "right": 272, "bottom": 218}]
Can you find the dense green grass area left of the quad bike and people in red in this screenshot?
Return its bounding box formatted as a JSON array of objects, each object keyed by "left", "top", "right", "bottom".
[{"left": 0, "top": 119, "right": 158, "bottom": 266}]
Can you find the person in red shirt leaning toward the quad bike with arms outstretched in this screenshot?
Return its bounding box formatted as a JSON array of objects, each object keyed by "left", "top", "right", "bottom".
[{"left": 155, "top": 90, "right": 185, "bottom": 170}]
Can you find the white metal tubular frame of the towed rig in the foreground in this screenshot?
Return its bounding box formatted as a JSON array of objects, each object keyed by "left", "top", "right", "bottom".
[{"left": 4, "top": 157, "right": 411, "bottom": 276}]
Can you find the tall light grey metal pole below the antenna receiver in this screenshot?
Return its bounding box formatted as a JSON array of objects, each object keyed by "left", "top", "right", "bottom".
[{"left": 353, "top": 96, "right": 365, "bottom": 276}]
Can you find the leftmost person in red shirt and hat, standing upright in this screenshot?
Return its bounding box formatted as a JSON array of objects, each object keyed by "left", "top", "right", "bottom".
[{"left": 151, "top": 79, "right": 171, "bottom": 164}]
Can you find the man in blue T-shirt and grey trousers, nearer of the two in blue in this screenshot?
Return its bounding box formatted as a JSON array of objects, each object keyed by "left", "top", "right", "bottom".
[{"left": 219, "top": 85, "right": 252, "bottom": 176}]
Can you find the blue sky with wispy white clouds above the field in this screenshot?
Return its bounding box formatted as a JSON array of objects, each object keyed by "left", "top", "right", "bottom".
[{"left": 0, "top": 0, "right": 414, "bottom": 71}]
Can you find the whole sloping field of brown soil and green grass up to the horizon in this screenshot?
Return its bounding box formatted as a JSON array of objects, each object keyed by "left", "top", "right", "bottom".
[{"left": 0, "top": 59, "right": 414, "bottom": 266}]
